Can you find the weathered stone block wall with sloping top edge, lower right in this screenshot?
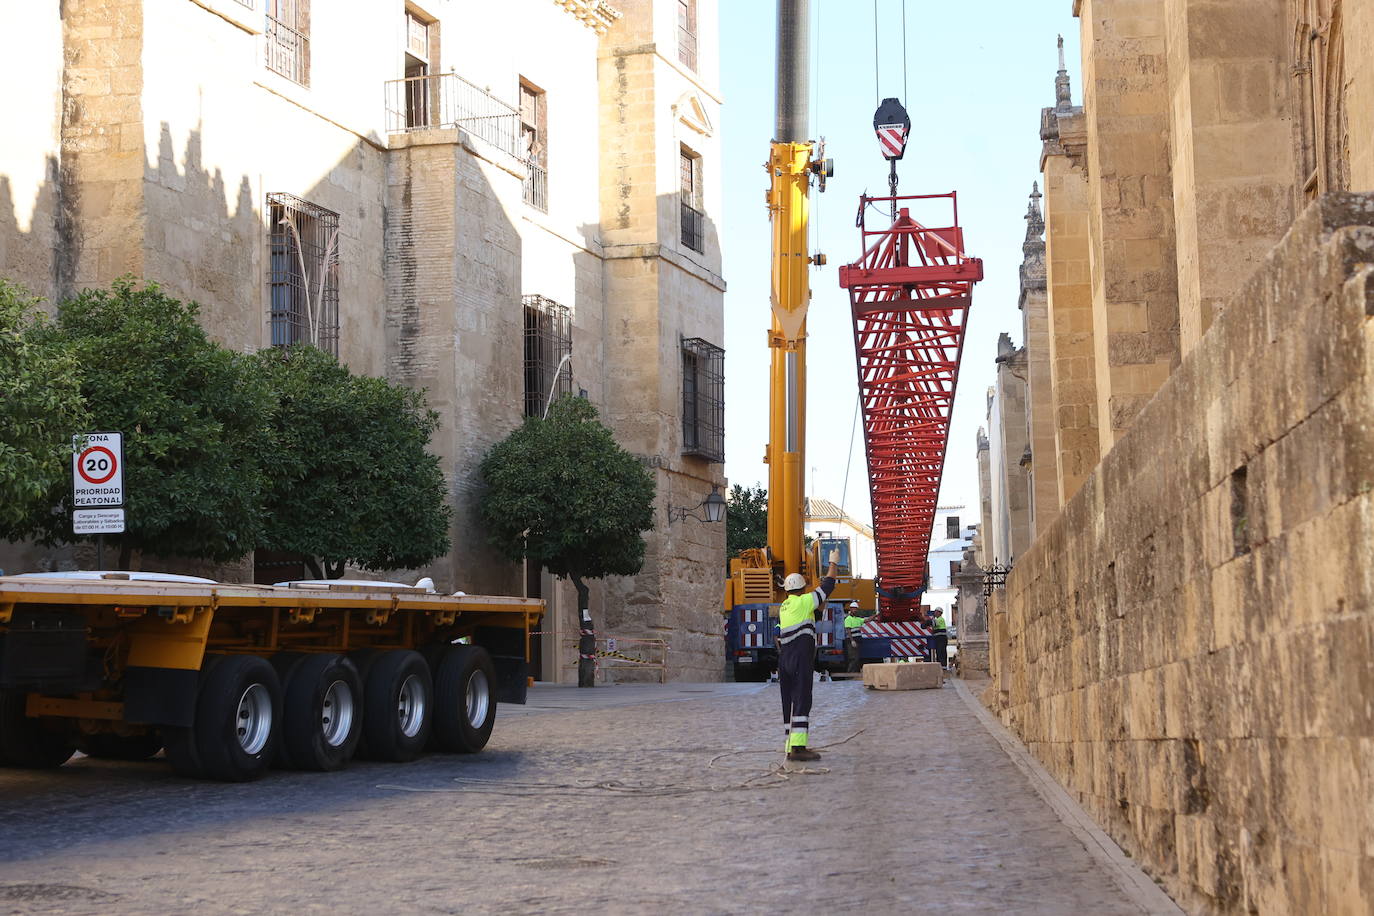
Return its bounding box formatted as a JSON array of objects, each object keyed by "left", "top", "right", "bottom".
[{"left": 987, "top": 194, "right": 1374, "bottom": 913}]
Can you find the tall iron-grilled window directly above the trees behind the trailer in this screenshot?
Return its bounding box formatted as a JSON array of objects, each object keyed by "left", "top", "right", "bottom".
[{"left": 267, "top": 194, "right": 339, "bottom": 356}]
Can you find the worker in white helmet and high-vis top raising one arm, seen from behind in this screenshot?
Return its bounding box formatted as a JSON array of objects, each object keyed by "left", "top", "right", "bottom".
[{"left": 778, "top": 551, "right": 840, "bottom": 761}]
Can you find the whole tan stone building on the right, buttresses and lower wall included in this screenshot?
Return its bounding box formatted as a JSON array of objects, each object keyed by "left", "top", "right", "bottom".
[{"left": 980, "top": 0, "right": 1374, "bottom": 913}]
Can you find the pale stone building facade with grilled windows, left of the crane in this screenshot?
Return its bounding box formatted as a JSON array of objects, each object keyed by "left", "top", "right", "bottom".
[{"left": 0, "top": 0, "right": 725, "bottom": 680}]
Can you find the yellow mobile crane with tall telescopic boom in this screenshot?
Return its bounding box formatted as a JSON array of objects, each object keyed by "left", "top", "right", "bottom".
[{"left": 724, "top": 0, "right": 874, "bottom": 681}]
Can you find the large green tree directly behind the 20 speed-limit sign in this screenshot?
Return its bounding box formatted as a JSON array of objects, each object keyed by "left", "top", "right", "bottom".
[{"left": 24, "top": 277, "right": 269, "bottom": 567}]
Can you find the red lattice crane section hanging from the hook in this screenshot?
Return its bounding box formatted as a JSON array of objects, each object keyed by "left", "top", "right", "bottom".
[{"left": 840, "top": 194, "right": 982, "bottom": 621}]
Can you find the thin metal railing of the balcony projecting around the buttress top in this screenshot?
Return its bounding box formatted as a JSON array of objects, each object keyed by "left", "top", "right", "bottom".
[{"left": 386, "top": 73, "right": 525, "bottom": 159}]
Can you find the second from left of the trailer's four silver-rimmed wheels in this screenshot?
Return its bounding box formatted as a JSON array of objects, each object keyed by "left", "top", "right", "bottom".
[{"left": 280, "top": 655, "right": 363, "bottom": 770}]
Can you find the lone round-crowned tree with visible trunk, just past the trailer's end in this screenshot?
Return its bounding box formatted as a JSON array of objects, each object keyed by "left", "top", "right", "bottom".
[{"left": 480, "top": 397, "right": 654, "bottom": 687}]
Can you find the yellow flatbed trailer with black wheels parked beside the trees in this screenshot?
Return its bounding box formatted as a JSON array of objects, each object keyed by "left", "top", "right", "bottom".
[{"left": 0, "top": 574, "right": 544, "bottom": 781}]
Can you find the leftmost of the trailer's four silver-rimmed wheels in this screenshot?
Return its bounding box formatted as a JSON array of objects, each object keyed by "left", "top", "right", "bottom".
[{"left": 175, "top": 655, "right": 282, "bottom": 783}]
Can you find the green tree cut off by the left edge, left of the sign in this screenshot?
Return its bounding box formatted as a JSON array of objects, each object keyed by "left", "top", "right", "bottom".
[{"left": 0, "top": 280, "right": 89, "bottom": 540}]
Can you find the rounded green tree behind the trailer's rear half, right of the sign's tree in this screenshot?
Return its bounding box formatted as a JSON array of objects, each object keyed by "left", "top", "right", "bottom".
[{"left": 254, "top": 346, "right": 449, "bottom": 578}]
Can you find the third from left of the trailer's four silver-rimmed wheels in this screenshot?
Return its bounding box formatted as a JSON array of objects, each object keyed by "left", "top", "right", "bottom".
[{"left": 361, "top": 650, "right": 434, "bottom": 762}]
